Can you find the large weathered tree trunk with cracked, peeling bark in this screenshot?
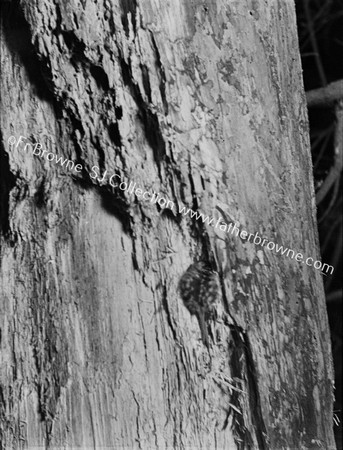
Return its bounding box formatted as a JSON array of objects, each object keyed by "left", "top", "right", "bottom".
[{"left": 0, "top": 0, "right": 335, "bottom": 450}]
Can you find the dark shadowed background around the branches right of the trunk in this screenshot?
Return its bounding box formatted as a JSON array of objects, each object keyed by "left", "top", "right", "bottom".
[{"left": 296, "top": 0, "right": 343, "bottom": 450}]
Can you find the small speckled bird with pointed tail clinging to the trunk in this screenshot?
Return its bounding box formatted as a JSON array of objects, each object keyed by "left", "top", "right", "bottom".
[{"left": 178, "top": 261, "right": 222, "bottom": 348}]
